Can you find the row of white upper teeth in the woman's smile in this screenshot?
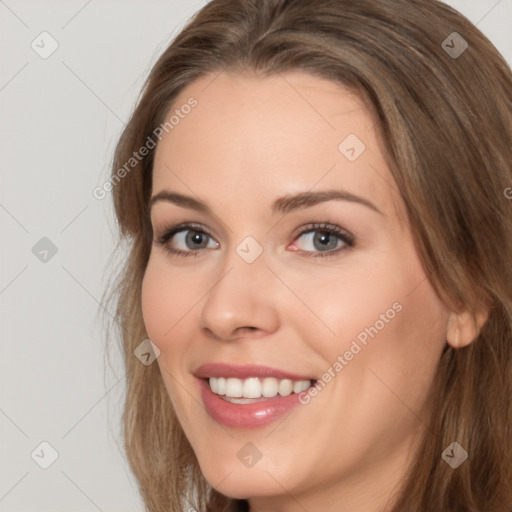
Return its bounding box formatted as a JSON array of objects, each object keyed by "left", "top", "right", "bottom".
[{"left": 208, "top": 377, "right": 312, "bottom": 403}]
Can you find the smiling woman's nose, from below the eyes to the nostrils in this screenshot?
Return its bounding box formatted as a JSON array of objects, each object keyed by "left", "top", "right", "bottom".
[{"left": 200, "top": 250, "right": 279, "bottom": 341}]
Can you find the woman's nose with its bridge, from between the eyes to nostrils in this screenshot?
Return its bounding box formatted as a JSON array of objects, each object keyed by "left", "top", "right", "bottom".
[{"left": 201, "top": 237, "right": 278, "bottom": 339}]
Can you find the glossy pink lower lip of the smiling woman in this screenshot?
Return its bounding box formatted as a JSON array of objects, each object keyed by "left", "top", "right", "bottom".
[{"left": 198, "top": 379, "right": 301, "bottom": 428}]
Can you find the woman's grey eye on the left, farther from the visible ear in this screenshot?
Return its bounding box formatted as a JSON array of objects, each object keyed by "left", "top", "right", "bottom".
[{"left": 155, "top": 224, "right": 219, "bottom": 256}]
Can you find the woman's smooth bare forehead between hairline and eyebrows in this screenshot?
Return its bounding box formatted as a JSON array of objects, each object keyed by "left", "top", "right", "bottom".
[{"left": 153, "top": 71, "right": 404, "bottom": 224}]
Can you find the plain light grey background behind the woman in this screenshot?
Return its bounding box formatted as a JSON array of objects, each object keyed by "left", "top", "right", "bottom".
[{"left": 0, "top": 0, "right": 512, "bottom": 512}]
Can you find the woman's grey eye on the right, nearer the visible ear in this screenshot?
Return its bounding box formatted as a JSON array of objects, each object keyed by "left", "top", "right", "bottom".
[{"left": 292, "top": 224, "right": 355, "bottom": 258}]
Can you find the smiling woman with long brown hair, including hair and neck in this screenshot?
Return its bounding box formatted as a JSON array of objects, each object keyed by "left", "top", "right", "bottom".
[{"left": 104, "top": 0, "right": 512, "bottom": 512}]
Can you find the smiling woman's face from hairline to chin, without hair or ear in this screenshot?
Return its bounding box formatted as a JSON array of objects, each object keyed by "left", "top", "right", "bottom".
[{"left": 142, "top": 71, "right": 448, "bottom": 511}]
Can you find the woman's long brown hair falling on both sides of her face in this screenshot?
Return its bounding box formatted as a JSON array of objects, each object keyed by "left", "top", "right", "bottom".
[{"left": 103, "top": 0, "right": 512, "bottom": 512}]
